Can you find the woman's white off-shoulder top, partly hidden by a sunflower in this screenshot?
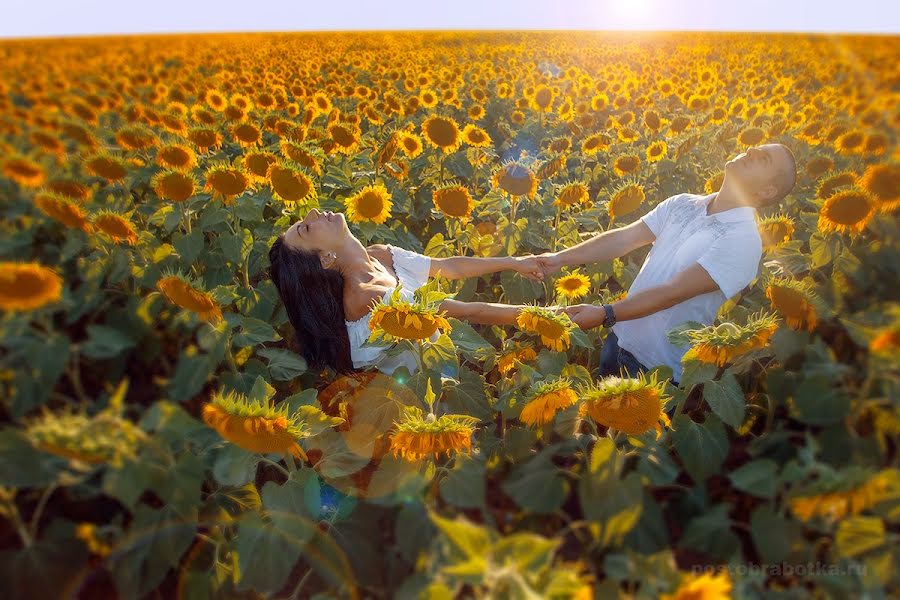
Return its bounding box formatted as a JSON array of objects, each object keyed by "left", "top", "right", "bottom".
[{"left": 344, "top": 244, "right": 438, "bottom": 375}]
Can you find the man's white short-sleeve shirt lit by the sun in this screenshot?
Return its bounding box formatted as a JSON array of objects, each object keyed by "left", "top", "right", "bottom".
[{"left": 612, "top": 193, "right": 762, "bottom": 381}]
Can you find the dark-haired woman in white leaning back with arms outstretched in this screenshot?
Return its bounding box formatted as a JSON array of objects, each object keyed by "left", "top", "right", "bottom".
[{"left": 269, "top": 209, "right": 543, "bottom": 374}]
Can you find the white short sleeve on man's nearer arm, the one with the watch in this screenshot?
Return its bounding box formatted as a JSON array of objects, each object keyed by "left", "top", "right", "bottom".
[{"left": 697, "top": 230, "right": 762, "bottom": 298}]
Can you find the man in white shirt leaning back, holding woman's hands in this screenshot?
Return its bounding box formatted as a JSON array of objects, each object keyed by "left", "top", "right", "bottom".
[{"left": 537, "top": 144, "right": 797, "bottom": 384}]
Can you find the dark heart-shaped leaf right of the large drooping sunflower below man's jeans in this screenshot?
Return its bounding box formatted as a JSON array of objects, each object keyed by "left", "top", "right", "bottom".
[{"left": 672, "top": 415, "right": 728, "bottom": 483}]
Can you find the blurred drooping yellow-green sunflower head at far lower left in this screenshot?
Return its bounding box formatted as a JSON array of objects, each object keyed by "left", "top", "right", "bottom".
[{"left": 25, "top": 406, "right": 147, "bottom": 465}]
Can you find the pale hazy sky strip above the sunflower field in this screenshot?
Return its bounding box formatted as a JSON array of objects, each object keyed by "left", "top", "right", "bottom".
[{"left": 0, "top": 0, "right": 900, "bottom": 38}]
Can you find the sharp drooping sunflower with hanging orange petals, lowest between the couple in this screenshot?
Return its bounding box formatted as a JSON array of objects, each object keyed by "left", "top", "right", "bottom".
[{"left": 390, "top": 404, "right": 478, "bottom": 462}]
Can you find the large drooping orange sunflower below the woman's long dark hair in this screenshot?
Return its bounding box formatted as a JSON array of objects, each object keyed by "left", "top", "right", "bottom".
[{"left": 203, "top": 390, "right": 344, "bottom": 460}]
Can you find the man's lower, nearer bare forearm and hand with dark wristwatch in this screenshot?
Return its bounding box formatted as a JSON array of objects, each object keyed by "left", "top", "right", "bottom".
[{"left": 566, "top": 263, "right": 719, "bottom": 329}]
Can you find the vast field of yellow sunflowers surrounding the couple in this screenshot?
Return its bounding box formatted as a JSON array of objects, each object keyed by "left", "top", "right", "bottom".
[{"left": 0, "top": 31, "right": 900, "bottom": 600}]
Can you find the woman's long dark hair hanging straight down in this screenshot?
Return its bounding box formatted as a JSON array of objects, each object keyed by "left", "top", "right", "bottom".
[{"left": 269, "top": 234, "right": 353, "bottom": 373}]
